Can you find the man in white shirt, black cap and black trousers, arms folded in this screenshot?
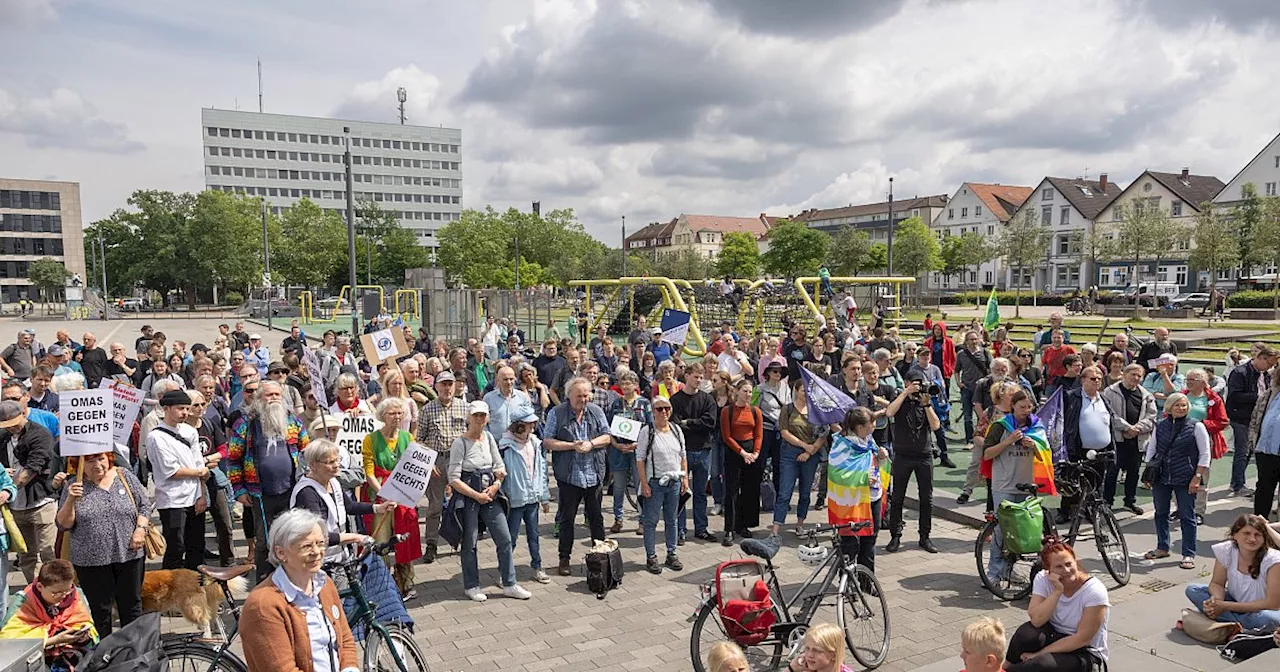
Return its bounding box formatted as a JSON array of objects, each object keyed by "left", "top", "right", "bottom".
[{"left": 146, "top": 389, "right": 209, "bottom": 571}]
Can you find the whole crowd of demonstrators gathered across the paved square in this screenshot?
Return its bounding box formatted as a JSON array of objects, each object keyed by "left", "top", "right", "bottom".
[{"left": 0, "top": 306, "right": 1280, "bottom": 669}]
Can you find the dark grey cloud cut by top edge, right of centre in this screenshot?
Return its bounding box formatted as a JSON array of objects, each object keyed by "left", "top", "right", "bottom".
[{"left": 699, "top": 0, "right": 905, "bottom": 38}]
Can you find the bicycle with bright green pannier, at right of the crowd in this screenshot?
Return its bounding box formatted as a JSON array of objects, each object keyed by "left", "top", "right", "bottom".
[{"left": 974, "top": 451, "right": 1132, "bottom": 602}]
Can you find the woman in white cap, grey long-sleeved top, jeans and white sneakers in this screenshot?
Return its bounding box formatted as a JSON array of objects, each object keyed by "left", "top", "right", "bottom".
[{"left": 449, "top": 401, "right": 529, "bottom": 602}]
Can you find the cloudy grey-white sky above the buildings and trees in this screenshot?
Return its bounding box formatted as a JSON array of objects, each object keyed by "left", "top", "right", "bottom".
[{"left": 0, "top": 0, "right": 1280, "bottom": 244}]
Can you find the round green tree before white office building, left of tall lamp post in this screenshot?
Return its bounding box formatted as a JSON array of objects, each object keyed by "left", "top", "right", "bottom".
[{"left": 271, "top": 198, "right": 347, "bottom": 287}]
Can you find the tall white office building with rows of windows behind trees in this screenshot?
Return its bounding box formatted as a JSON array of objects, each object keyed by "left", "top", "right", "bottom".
[{"left": 201, "top": 109, "right": 462, "bottom": 247}]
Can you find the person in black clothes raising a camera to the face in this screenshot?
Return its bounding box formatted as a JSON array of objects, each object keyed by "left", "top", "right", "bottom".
[{"left": 884, "top": 370, "right": 942, "bottom": 553}]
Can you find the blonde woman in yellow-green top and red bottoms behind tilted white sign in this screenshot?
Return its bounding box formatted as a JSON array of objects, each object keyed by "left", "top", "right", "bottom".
[{"left": 362, "top": 397, "right": 422, "bottom": 600}]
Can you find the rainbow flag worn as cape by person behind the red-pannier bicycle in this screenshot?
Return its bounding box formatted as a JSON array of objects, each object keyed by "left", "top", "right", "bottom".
[{"left": 827, "top": 434, "right": 891, "bottom": 536}]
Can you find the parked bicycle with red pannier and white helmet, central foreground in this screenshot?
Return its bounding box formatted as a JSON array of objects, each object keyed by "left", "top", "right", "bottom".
[{"left": 687, "top": 522, "right": 891, "bottom": 672}]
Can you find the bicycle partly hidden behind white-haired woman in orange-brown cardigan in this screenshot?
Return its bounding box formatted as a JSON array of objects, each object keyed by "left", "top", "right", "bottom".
[{"left": 160, "top": 535, "right": 430, "bottom": 672}]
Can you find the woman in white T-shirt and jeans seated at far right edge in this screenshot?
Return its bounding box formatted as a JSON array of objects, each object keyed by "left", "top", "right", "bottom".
[{"left": 1187, "top": 513, "right": 1280, "bottom": 631}]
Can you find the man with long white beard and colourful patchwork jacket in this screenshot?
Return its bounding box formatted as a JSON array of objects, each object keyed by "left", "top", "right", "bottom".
[{"left": 227, "top": 380, "right": 310, "bottom": 581}]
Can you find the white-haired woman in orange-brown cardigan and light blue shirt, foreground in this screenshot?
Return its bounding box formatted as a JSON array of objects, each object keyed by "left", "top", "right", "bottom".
[{"left": 239, "top": 508, "right": 360, "bottom": 672}]
